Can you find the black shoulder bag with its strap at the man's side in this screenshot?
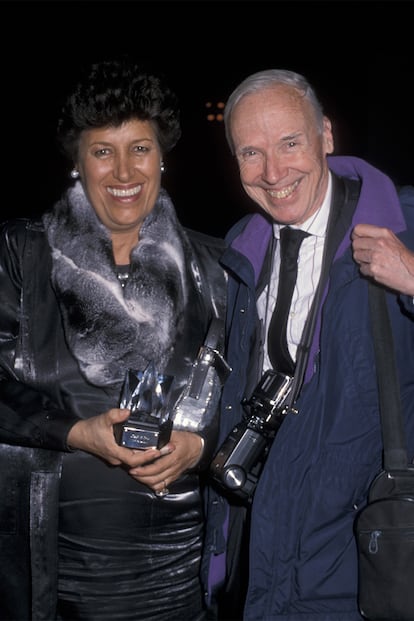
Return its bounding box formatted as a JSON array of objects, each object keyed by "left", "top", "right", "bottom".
[{"left": 355, "top": 283, "right": 414, "bottom": 621}]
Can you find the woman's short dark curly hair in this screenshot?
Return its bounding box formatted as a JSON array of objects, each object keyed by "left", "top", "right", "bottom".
[{"left": 57, "top": 58, "right": 181, "bottom": 162}]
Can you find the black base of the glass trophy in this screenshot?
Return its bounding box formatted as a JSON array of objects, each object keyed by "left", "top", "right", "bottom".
[{"left": 115, "top": 419, "right": 172, "bottom": 450}]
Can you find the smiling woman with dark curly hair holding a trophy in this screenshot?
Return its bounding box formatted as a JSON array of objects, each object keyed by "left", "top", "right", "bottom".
[{"left": 0, "top": 59, "right": 225, "bottom": 621}]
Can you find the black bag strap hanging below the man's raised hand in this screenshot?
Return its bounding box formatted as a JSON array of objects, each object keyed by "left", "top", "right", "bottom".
[{"left": 368, "top": 281, "right": 408, "bottom": 470}]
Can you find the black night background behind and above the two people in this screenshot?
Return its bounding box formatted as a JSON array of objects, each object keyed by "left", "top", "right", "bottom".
[{"left": 0, "top": 0, "right": 414, "bottom": 235}]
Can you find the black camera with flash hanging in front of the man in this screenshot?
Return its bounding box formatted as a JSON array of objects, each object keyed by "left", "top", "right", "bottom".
[{"left": 210, "top": 370, "right": 293, "bottom": 502}]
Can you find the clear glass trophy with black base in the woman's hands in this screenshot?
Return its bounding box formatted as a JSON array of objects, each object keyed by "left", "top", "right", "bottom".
[{"left": 114, "top": 362, "right": 174, "bottom": 449}]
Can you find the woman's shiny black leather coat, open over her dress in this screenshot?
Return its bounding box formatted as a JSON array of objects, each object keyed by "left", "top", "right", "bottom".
[{"left": 0, "top": 220, "right": 225, "bottom": 621}]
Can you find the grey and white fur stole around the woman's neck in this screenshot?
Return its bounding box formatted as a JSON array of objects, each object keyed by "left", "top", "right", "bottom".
[{"left": 43, "top": 182, "right": 196, "bottom": 386}]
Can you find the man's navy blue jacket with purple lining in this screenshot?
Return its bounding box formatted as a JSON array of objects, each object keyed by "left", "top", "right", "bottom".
[{"left": 204, "top": 157, "right": 414, "bottom": 621}]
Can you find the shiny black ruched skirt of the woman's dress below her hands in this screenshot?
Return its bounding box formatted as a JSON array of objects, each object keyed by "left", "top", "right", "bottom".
[{"left": 58, "top": 451, "right": 205, "bottom": 621}]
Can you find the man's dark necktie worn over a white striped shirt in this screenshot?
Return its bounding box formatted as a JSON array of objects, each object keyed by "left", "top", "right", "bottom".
[{"left": 267, "top": 226, "right": 309, "bottom": 375}]
